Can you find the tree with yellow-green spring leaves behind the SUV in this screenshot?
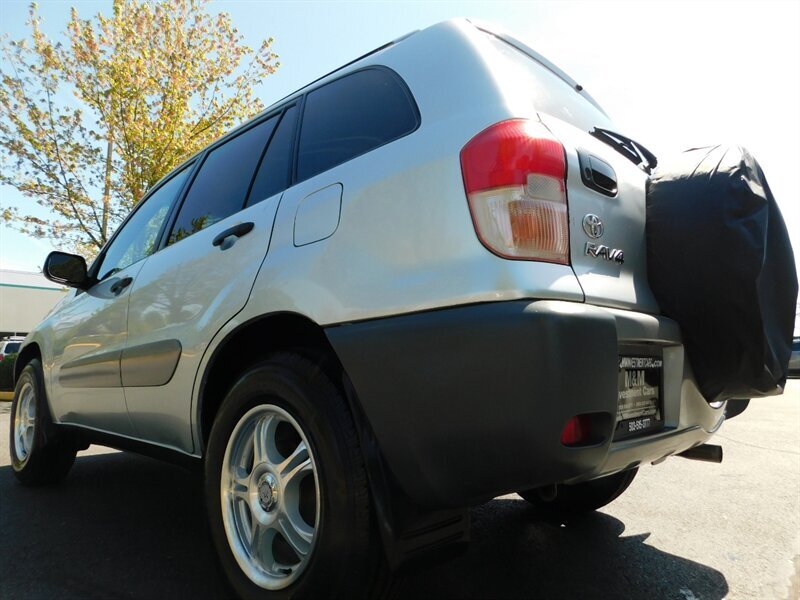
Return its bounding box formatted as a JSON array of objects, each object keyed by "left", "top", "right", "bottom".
[{"left": 0, "top": 0, "right": 279, "bottom": 255}]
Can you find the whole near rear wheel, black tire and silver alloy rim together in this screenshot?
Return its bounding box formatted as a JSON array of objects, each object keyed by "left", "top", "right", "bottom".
[{"left": 204, "top": 352, "right": 388, "bottom": 598}]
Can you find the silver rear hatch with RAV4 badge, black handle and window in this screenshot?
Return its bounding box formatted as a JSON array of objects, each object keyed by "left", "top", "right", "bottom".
[{"left": 487, "top": 32, "right": 658, "bottom": 313}]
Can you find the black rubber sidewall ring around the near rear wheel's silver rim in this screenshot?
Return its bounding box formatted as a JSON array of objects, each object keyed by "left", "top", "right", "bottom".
[{"left": 204, "top": 362, "right": 356, "bottom": 598}]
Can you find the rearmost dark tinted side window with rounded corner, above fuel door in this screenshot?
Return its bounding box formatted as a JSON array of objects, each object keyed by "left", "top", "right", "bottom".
[{"left": 297, "top": 69, "right": 419, "bottom": 180}]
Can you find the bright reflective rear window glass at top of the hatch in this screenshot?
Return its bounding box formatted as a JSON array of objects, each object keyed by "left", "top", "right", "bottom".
[{"left": 487, "top": 33, "right": 613, "bottom": 131}]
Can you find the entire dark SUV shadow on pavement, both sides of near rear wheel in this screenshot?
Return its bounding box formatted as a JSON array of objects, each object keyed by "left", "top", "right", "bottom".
[{"left": 0, "top": 453, "right": 728, "bottom": 600}]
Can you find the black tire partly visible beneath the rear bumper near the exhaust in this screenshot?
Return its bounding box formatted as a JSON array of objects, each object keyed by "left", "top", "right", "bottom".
[{"left": 518, "top": 468, "right": 639, "bottom": 516}]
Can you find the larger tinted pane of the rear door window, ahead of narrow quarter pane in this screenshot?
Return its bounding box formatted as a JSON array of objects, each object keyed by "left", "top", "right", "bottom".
[{"left": 169, "top": 115, "right": 278, "bottom": 244}]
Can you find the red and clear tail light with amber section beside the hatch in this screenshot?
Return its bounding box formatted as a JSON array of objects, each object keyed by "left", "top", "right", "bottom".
[{"left": 461, "top": 119, "right": 569, "bottom": 265}]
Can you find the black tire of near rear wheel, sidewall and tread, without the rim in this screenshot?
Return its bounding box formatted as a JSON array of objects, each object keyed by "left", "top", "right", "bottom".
[{"left": 204, "top": 354, "right": 389, "bottom": 599}]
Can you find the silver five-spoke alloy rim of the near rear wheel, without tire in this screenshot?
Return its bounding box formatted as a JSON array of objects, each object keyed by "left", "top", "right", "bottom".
[{"left": 220, "top": 404, "right": 320, "bottom": 590}]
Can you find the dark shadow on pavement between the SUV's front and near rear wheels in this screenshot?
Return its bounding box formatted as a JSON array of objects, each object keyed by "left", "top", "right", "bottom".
[{"left": 0, "top": 452, "right": 228, "bottom": 600}]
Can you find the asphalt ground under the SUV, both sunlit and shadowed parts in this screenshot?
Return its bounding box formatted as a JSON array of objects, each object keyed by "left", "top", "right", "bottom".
[{"left": 0, "top": 381, "right": 800, "bottom": 600}]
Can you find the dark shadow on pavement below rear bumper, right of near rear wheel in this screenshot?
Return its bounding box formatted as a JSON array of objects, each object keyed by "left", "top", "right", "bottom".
[{"left": 401, "top": 499, "right": 728, "bottom": 600}]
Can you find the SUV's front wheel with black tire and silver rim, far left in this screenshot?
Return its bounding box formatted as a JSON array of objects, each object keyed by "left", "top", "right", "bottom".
[{"left": 8, "top": 358, "right": 77, "bottom": 486}]
